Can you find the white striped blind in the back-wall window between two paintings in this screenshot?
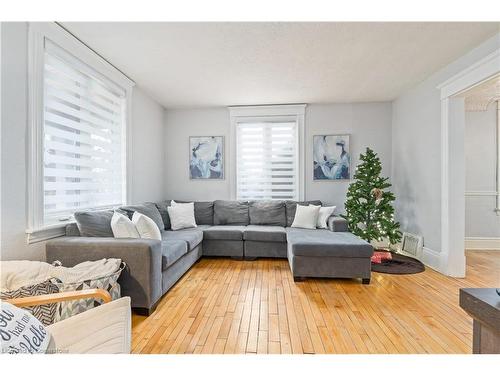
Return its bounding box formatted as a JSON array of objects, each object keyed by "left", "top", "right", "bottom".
[{"left": 236, "top": 121, "right": 299, "bottom": 200}]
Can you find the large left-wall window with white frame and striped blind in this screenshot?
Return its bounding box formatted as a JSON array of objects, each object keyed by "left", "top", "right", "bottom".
[{"left": 28, "top": 24, "right": 131, "bottom": 240}]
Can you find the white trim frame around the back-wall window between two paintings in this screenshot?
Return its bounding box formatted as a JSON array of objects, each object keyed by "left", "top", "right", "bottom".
[{"left": 229, "top": 104, "right": 306, "bottom": 200}]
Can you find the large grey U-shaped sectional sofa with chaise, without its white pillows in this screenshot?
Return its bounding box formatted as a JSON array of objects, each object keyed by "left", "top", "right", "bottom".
[{"left": 46, "top": 200, "right": 373, "bottom": 315}]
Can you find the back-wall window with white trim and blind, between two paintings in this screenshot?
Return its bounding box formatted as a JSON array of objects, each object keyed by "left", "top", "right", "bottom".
[{"left": 230, "top": 105, "right": 305, "bottom": 200}]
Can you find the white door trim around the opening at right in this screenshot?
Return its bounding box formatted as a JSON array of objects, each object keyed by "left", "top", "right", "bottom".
[{"left": 437, "top": 49, "right": 500, "bottom": 277}]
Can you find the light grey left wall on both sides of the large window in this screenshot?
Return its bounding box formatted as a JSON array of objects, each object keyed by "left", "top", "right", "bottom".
[{"left": 0, "top": 22, "right": 165, "bottom": 260}]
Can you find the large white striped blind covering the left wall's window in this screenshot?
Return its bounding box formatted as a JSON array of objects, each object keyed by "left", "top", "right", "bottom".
[{"left": 43, "top": 39, "right": 126, "bottom": 225}]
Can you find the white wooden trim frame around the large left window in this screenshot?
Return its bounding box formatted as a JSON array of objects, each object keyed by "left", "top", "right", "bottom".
[{"left": 26, "top": 22, "right": 135, "bottom": 243}]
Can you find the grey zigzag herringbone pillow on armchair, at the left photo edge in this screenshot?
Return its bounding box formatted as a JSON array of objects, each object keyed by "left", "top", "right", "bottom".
[{"left": 0, "top": 280, "right": 59, "bottom": 326}]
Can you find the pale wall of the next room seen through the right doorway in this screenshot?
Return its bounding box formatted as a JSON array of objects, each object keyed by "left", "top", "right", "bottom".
[{"left": 465, "top": 103, "right": 500, "bottom": 238}]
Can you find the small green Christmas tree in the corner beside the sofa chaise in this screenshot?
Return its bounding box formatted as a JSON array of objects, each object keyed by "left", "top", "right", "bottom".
[{"left": 342, "top": 148, "right": 401, "bottom": 244}]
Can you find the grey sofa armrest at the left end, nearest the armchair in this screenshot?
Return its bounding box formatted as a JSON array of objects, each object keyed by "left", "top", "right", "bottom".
[{"left": 45, "top": 237, "right": 162, "bottom": 309}]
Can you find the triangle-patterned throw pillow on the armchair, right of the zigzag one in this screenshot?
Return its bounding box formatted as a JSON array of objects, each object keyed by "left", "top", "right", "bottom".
[{"left": 54, "top": 262, "right": 126, "bottom": 322}]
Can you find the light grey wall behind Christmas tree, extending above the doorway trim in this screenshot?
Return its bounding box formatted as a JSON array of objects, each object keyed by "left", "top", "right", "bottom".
[{"left": 392, "top": 34, "right": 500, "bottom": 252}]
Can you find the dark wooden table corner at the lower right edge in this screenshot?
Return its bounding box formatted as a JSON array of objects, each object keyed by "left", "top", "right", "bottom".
[{"left": 460, "top": 288, "right": 500, "bottom": 354}]
